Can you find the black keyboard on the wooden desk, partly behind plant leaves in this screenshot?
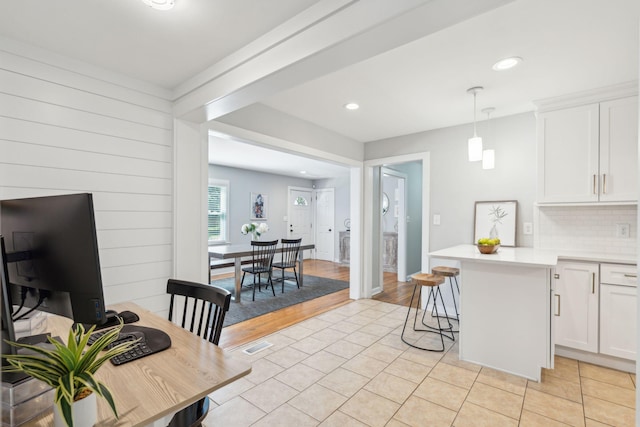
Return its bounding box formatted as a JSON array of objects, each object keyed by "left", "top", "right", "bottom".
[{"left": 89, "top": 325, "right": 171, "bottom": 365}]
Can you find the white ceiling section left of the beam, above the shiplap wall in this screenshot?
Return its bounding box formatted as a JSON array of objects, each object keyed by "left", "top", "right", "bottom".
[{"left": 0, "top": 0, "right": 318, "bottom": 89}]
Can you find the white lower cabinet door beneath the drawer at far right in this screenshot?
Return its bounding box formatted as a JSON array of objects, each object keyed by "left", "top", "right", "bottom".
[{"left": 600, "top": 284, "right": 637, "bottom": 360}]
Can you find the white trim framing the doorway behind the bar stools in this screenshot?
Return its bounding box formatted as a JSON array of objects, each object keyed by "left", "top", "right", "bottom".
[{"left": 362, "top": 151, "right": 431, "bottom": 298}]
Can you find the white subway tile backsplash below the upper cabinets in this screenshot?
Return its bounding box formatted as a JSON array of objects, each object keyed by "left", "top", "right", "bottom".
[{"left": 534, "top": 206, "right": 638, "bottom": 255}]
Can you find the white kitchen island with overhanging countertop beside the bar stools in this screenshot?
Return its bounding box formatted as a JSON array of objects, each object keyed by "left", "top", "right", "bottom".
[{"left": 429, "top": 245, "right": 558, "bottom": 381}]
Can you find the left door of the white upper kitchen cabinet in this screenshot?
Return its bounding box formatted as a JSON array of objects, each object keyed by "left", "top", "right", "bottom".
[{"left": 537, "top": 103, "right": 600, "bottom": 203}]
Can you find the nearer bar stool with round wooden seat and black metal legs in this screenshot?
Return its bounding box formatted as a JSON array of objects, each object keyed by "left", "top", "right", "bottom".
[{"left": 400, "top": 273, "right": 455, "bottom": 352}]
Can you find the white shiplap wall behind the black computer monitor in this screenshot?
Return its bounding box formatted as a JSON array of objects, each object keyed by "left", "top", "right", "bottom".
[{"left": 0, "top": 40, "right": 173, "bottom": 313}]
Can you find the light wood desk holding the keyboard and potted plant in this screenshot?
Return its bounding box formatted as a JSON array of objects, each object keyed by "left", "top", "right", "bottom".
[{"left": 24, "top": 303, "right": 251, "bottom": 427}]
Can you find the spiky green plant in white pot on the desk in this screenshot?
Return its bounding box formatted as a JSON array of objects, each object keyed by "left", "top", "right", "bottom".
[{"left": 2, "top": 324, "right": 138, "bottom": 427}]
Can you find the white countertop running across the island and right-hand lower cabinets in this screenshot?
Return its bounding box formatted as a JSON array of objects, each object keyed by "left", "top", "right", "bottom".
[{"left": 429, "top": 245, "right": 637, "bottom": 267}]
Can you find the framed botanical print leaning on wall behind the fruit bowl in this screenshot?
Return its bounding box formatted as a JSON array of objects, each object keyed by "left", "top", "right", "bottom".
[{"left": 473, "top": 200, "right": 518, "bottom": 246}]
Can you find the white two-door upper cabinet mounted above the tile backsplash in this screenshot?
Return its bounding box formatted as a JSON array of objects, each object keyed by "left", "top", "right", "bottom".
[{"left": 537, "top": 96, "right": 638, "bottom": 203}]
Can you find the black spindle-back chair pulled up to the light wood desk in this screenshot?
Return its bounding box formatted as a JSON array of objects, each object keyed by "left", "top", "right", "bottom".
[{"left": 167, "top": 279, "right": 231, "bottom": 427}]
